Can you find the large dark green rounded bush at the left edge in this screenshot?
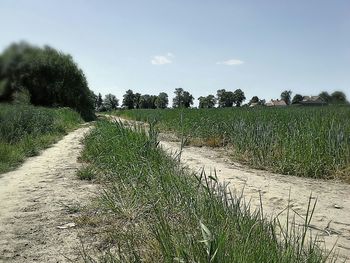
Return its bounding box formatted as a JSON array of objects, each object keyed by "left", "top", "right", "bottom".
[{"left": 0, "top": 42, "right": 95, "bottom": 120}]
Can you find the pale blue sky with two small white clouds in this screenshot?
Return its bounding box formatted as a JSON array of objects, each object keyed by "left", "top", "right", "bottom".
[{"left": 0, "top": 0, "right": 350, "bottom": 105}]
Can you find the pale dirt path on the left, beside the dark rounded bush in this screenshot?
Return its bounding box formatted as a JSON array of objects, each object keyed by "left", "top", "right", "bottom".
[{"left": 0, "top": 127, "right": 96, "bottom": 263}]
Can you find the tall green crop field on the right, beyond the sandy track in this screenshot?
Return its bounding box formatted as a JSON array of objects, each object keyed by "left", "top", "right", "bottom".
[{"left": 113, "top": 106, "right": 350, "bottom": 180}]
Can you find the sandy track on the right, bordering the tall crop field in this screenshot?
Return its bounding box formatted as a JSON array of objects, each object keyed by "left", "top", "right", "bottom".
[{"left": 160, "top": 140, "right": 350, "bottom": 258}]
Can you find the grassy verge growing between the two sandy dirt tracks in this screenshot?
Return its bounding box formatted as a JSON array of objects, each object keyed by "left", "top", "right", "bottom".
[{"left": 80, "top": 121, "right": 332, "bottom": 263}]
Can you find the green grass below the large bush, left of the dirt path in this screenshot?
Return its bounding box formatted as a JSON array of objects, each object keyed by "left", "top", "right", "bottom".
[{"left": 0, "top": 104, "right": 83, "bottom": 173}]
